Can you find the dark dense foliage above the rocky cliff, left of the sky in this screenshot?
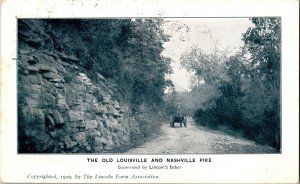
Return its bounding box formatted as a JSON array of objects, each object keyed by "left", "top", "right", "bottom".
[{"left": 45, "top": 19, "right": 171, "bottom": 113}]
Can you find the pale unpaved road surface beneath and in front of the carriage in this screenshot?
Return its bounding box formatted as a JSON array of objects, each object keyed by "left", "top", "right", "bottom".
[{"left": 126, "top": 117, "right": 275, "bottom": 154}]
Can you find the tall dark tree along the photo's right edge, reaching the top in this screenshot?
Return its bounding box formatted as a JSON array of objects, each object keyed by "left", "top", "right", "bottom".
[{"left": 241, "top": 17, "right": 281, "bottom": 149}]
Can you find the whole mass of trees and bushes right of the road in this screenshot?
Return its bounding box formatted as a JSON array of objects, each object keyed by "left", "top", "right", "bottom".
[{"left": 181, "top": 18, "right": 281, "bottom": 150}]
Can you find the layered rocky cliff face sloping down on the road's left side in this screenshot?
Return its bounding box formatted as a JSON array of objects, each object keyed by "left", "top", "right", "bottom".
[{"left": 18, "top": 20, "right": 139, "bottom": 153}]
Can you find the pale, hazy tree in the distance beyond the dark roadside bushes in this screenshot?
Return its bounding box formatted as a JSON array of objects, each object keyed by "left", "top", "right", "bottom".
[{"left": 181, "top": 47, "right": 228, "bottom": 110}]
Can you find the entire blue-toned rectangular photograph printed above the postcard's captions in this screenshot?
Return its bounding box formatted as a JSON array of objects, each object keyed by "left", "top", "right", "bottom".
[{"left": 17, "top": 17, "right": 281, "bottom": 155}]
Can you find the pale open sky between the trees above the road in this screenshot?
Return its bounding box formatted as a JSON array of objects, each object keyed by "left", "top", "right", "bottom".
[{"left": 163, "top": 18, "right": 253, "bottom": 91}]
